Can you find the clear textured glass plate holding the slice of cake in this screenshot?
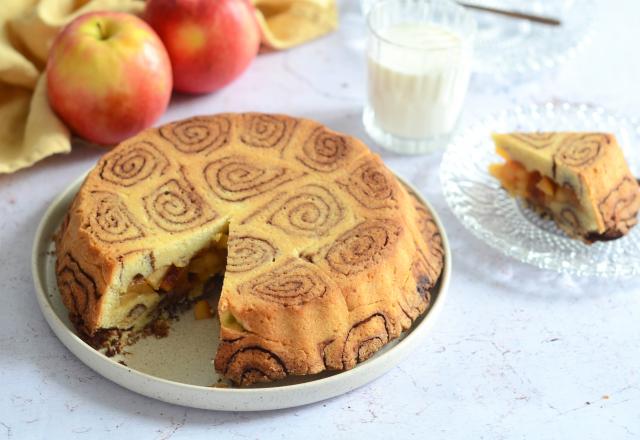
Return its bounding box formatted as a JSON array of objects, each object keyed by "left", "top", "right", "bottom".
[{"left": 440, "top": 103, "right": 640, "bottom": 277}]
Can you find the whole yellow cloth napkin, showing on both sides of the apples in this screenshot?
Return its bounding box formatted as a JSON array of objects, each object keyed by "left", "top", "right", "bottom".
[{"left": 0, "top": 0, "right": 338, "bottom": 173}]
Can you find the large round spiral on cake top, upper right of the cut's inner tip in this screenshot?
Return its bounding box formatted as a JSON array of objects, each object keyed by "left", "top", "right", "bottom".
[{"left": 268, "top": 184, "right": 344, "bottom": 237}]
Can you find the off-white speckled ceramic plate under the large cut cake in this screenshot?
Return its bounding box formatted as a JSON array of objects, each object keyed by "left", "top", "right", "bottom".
[{"left": 32, "top": 173, "right": 451, "bottom": 411}]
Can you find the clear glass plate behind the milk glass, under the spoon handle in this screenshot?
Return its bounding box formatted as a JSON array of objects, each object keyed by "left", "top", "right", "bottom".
[{"left": 469, "top": 0, "right": 595, "bottom": 80}]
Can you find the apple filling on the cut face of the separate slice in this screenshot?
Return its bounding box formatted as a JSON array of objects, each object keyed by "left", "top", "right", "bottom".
[{"left": 489, "top": 148, "right": 581, "bottom": 211}]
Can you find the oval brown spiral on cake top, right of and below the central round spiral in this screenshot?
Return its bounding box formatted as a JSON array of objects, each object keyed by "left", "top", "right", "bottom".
[{"left": 325, "top": 220, "right": 400, "bottom": 275}]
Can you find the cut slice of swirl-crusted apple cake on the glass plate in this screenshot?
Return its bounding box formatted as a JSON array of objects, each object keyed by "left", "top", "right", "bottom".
[{"left": 489, "top": 132, "right": 640, "bottom": 243}]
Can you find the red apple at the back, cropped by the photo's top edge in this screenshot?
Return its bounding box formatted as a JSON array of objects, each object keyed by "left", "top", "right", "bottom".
[{"left": 144, "top": 0, "right": 260, "bottom": 93}]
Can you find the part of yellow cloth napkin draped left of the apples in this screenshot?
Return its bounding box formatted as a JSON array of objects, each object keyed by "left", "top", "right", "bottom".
[{"left": 0, "top": 0, "right": 144, "bottom": 173}]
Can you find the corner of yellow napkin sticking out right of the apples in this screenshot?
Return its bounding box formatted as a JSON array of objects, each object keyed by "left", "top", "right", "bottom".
[{"left": 253, "top": 0, "right": 338, "bottom": 49}]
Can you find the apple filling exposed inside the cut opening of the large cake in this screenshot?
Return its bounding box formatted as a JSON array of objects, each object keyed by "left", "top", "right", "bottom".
[{"left": 118, "top": 232, "right": 228, "bottom": 329}]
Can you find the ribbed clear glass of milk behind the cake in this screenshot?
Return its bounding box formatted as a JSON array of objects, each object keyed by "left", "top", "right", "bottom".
[{"left": 363, "top": 0, "right": 476, "bottom": 154}]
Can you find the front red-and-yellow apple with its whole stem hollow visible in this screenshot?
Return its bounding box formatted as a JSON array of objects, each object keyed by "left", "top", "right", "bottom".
[{"left": 47, "top": 12, "right": 172, "bottom": 145}]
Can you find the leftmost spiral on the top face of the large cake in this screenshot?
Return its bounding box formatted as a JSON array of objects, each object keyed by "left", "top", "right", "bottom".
[{"left": 89, "top": 191, "right": 144, "bottom": 243}]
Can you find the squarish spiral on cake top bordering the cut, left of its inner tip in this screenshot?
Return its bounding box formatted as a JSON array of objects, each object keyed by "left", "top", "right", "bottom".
[{"left": 144, "top": 175, "right": 215, "bottom": 232}]
